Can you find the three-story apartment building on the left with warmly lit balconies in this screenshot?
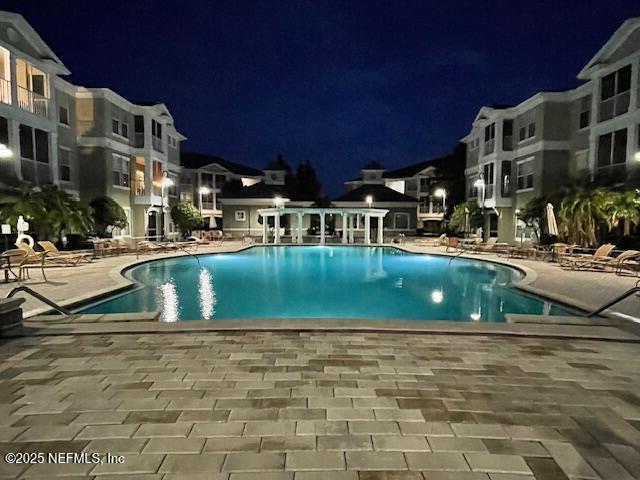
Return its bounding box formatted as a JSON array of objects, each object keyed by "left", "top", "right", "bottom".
[{"left": 0, "top": 12, "right": 185, "bottom": 237}]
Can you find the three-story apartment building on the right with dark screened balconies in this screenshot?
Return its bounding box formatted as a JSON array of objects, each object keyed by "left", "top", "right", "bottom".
[{"left": 462, "top": 18, "right": 640, "bottom": 242}]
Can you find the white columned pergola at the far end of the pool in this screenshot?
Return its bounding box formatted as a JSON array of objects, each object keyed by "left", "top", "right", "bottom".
[{"left": 258, "top": 207, "right": 389, "bottom": 245}]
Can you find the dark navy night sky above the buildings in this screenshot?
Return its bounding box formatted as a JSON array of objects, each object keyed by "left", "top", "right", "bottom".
[{"left": 5, "top": 0, "right": 640, "bottom": 195}]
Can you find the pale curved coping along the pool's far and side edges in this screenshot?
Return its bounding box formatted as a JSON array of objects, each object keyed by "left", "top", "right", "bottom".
[{"left": 25, "top": 243, "right": 610, "bottom": 324}]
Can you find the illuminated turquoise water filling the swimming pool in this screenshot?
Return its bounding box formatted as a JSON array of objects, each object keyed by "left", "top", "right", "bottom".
[{"left": 82, "top": 246, "right": 570, "bottom": 322}]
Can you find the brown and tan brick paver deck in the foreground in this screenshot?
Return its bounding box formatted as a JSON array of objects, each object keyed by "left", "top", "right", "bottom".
[{"left": 0, "top": 332, "right": 640, "bottom": 480}]
